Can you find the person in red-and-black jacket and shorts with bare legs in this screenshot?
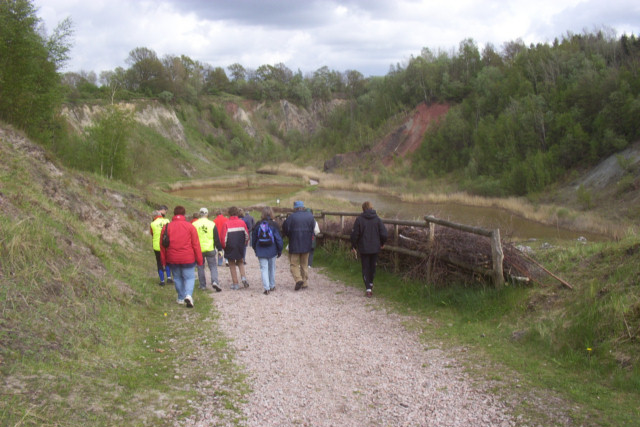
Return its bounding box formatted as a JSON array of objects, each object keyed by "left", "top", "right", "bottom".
[{"left": 220, "top": 206, "right": 249, "bottom": 290}]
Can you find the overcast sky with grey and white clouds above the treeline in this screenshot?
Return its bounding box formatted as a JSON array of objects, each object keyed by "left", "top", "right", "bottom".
[{"left": 34, "top": 0, "right": 640, "bottom": 76}]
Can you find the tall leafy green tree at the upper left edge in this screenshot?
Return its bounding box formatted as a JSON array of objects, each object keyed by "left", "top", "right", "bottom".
[{"left": 0, "top": 0, "right": 71, "bottom": 136}]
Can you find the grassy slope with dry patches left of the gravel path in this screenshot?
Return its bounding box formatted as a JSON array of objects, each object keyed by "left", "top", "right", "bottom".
[{"left": 0, "top": 135, "right": 247, "bottom": 426}]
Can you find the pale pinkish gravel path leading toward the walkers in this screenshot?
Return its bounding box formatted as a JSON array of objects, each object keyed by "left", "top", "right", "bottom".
[{"left": 186, "top": 249, "right": 516, "bottom": 427}]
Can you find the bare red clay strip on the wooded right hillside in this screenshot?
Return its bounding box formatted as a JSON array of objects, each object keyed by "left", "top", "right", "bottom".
[{"left": 371, "top": 102, "right": 449, "bottom": 166}]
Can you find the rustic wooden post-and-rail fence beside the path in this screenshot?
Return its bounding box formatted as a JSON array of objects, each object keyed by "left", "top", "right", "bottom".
[{"left": 315, "top": 211, "right": 504, "bottom": 288}]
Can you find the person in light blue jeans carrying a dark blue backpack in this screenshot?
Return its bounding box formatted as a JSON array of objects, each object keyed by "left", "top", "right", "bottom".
[{"left": 251, "top": 206, "right": 283, "bottom": 295}]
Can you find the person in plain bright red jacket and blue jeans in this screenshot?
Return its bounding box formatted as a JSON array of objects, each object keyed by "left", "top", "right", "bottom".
[{"left": 160, "top": 206, "right": 203, "bottom": 308}]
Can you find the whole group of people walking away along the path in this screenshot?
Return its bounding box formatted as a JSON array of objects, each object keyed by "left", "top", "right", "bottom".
[{"left": 150, "top": 201, "right": 387, "bottom": 308}]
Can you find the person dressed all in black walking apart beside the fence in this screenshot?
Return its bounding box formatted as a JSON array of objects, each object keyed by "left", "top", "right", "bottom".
[{"left": 351, "top": 201, "right": 387, "bottom": 297}]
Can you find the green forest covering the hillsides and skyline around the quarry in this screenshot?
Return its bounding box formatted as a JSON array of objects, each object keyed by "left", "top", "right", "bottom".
[{"left": 0, "top": 0, "right": 640, "bottom": 196}]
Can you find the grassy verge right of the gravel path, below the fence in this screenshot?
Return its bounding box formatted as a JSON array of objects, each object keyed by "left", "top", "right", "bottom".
[{"left": 314, "top": 236, "right": 640, "bottom": 426}]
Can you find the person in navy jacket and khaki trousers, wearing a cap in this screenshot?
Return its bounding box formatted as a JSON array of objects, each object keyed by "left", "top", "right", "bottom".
[{"left": 282, "top": 200, "right": 316, "bottom": 291}]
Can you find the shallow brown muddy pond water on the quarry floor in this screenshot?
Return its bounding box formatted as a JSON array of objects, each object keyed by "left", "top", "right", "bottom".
[{"left": 169, "top": 186, "right": 605, "bottom": 241}]
